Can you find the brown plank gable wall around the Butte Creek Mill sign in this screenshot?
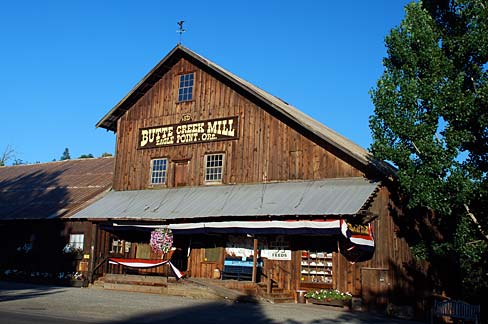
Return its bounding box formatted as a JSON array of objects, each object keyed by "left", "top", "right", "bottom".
[{"left": 114, "top": 59, "right": 363, "bottom": 190}]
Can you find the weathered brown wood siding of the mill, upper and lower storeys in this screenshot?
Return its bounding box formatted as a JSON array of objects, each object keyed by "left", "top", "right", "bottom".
[{"left": 106, "top": 55, "right": 410, "bottom": 304}]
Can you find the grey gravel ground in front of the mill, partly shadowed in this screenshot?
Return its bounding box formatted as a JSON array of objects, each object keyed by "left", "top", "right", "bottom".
[{"left": 0, "top": 281, "right": 419, "bottom": 324}]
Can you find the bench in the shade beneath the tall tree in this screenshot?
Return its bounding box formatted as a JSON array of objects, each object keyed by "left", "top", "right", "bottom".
[{"left": 430, "top": 299, "right": 480, "bottom": 324}]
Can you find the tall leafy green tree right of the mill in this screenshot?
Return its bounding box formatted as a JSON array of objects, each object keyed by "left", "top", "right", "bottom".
[{"left": 370, "top": 0, "right": 488, "bottom": 299}]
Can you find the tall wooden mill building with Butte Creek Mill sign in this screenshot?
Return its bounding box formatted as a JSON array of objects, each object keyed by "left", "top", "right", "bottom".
[{"left": 71, "top": 45, "right": 411, "bottom": 306}]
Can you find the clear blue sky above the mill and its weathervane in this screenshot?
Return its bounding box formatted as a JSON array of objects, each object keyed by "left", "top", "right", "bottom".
[{"left": 0, "top": 0, "right": 410, "bottom": 164}]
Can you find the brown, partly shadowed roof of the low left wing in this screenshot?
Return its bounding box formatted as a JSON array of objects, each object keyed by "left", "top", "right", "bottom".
[{"left": 0, "top": 157, "right": 115, "bottom": 220}]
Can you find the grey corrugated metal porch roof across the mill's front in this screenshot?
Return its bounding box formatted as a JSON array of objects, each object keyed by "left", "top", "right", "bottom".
[{"left": 72, "top": 178, "right": 379, "bottom": 221}]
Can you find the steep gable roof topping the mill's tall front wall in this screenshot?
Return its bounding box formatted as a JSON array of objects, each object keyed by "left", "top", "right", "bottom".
[{"left": 96, "top": 45, "right": 395, "bottom": 175}]
